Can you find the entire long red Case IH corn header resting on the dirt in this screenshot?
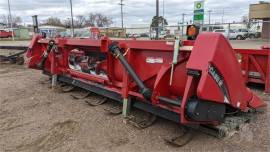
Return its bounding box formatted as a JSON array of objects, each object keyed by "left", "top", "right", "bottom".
[{"left": 27, "top": 33, "right": 269, "bottom": 145}]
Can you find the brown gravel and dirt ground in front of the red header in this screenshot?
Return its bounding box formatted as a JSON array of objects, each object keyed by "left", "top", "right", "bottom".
[{"left": 0, "top": 64, "right": 270, "bottom": 152}]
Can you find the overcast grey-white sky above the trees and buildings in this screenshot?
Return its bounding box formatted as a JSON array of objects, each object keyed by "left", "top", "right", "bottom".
[{"left": 0, "top": 0, "right": 270, "bottom": 27}]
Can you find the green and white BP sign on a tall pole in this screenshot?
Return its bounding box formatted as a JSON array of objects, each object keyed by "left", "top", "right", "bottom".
[{"left": 193, "top": 1, "right": 204, "bottom": 24}]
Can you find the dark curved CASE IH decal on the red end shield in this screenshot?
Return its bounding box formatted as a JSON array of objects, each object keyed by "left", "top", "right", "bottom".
[{"left": 208, "top": 64, "right": 230, "bottom": 104}]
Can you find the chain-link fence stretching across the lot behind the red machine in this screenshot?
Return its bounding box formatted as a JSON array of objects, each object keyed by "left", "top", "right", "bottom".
[{"left": 37, "top": 21, "right": 270, "bottom": 41}]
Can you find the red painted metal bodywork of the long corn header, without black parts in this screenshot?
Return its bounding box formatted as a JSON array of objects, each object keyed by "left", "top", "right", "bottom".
[{"left": 27, "top": 33, "right": 269, "bottom": 124}]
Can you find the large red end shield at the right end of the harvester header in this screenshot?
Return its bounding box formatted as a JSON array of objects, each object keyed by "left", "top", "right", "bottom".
[{"left": 187, "top": 34, "right": 252, "bottom": 110}]
